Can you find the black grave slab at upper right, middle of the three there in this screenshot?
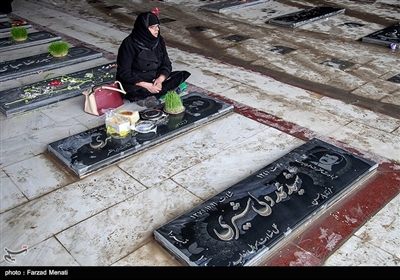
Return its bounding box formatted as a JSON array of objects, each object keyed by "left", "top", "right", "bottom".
[{"left": 268, "top": 7, "right": 345, "bottom": 27}]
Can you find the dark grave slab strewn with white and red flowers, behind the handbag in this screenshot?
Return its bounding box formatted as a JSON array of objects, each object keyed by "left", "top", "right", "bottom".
[{"left": 0, "top": 63, "right": 117, "bottom": 117}]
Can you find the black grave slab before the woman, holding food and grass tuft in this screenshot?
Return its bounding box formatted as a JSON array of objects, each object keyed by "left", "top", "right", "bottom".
[{"left": 48, "top": 92, "right": 233, "bottom": 177}]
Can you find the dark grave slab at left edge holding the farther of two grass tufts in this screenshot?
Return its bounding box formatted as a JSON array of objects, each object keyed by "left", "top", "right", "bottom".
[{"left": 0, "top": 31, "right": 61, "bottom": 52}]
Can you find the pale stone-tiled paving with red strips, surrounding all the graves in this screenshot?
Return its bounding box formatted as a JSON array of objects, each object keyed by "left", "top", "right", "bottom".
[{"left": 0, "top": 0, "right": 400, "bottom": 272}]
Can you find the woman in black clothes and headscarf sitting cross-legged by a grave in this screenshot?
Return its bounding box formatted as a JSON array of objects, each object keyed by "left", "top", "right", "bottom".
[{"left": 116, "top": 12, "right": 190, "bottom": 107}]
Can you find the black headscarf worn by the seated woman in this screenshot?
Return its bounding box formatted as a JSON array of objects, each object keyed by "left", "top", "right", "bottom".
[{"left": 131, "top": 12, "right": 160, "bottom": 50}]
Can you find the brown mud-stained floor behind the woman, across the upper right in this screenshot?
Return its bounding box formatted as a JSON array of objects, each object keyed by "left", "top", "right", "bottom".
[{"left": 34, "top": 0, "right": 400, "bottom": 118}]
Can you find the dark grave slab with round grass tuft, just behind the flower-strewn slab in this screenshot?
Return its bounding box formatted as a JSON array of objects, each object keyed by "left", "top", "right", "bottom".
[{"left": 0, "top": 46, "right": 103, "bottom": 82}]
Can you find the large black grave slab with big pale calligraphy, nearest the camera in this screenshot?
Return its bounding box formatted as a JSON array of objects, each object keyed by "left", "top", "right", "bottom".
[{"left": 154, "top": 138, "right": 378, "bottom": 266}]
